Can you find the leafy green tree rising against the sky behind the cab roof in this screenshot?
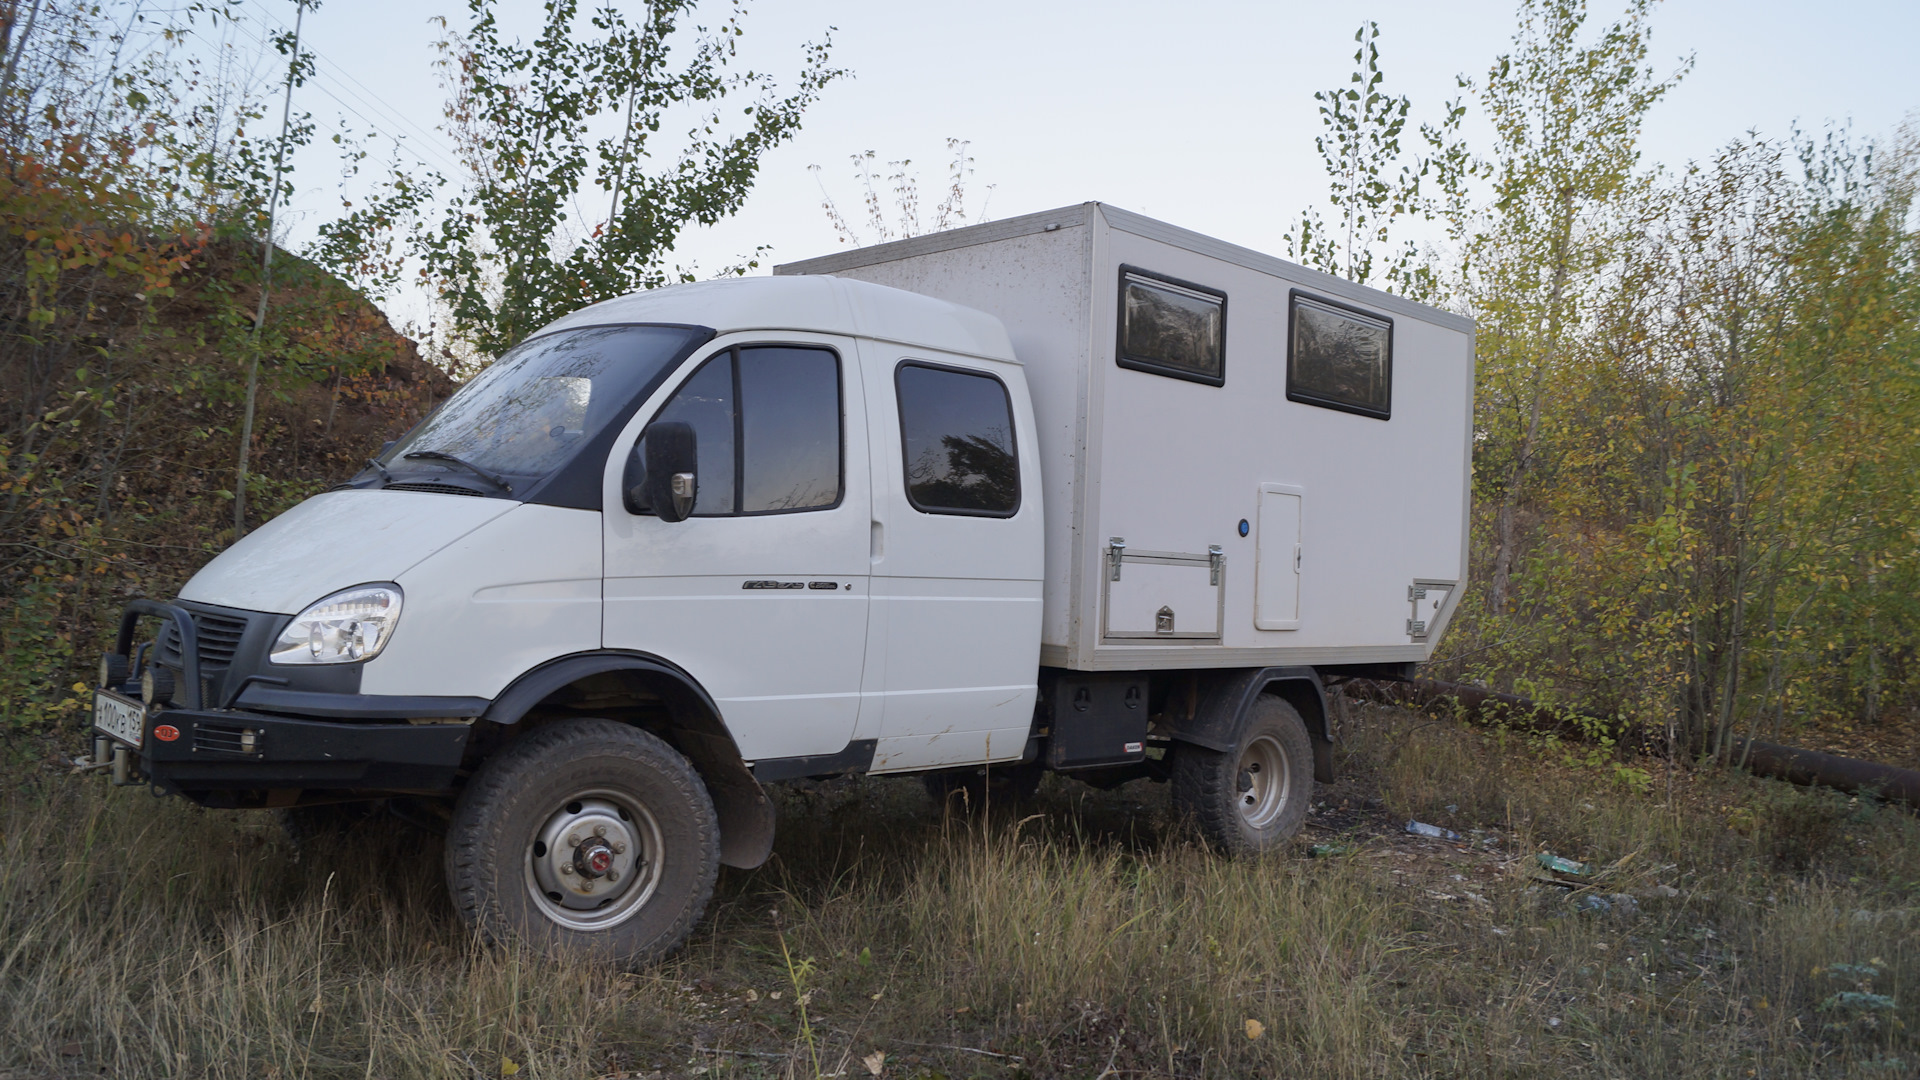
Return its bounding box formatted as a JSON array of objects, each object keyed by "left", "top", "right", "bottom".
[{"left": 413, "top": 0, "right": 843, "bottom": 356}]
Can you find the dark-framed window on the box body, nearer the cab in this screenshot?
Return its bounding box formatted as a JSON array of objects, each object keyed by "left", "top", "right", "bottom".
[{"left": 1116, "top": 265, "right": 1227, "bottom": 386}]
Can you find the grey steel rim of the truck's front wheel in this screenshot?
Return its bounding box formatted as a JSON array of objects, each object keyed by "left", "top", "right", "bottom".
[{"left": 522, "top": 788, "right": 664, "bottom": 930}]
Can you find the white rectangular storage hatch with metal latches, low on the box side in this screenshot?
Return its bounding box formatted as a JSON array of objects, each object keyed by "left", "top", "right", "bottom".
[{"left": 1100, "top": 536, "right": 1227, "bottom": 644}]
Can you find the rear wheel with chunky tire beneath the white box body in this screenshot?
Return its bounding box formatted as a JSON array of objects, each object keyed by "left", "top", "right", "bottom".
[{"left": 1173, "top": 694, "right": 1313, "bottom": 857}]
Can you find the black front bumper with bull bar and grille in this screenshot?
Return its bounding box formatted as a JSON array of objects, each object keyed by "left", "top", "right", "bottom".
[{"left": 108, "top": 600, "right": 490, "bottom": 807}]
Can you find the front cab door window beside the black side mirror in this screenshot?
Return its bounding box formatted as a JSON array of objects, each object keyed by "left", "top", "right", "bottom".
[{"left": 624, "top": 346, "right": 845, "bottom": 517}]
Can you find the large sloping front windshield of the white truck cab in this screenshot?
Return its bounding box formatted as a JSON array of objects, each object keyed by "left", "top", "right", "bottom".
[{"left": 380, "top": 319, "right": 705, "bottom": 490}]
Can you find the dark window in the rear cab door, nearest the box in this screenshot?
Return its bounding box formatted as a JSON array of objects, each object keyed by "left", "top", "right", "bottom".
[{"left": 893, "top": 361, "right": 1020, "bottom": 517}]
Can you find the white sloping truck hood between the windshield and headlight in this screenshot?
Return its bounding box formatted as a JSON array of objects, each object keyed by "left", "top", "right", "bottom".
[{"left": 180, "top": 490, "right": 520, "bottom": 615}]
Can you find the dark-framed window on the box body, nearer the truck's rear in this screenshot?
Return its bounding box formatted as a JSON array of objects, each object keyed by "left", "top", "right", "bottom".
[{"left": 1286, "top": 292, "right": 1394, "bottom": 421}]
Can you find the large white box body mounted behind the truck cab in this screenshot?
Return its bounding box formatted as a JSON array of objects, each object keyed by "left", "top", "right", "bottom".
[{"left": 774, "top": 204, "right": 1473, "bottom": 671}]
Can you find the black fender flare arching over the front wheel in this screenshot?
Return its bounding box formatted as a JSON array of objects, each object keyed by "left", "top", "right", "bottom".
[{"left": 480, "top": 650, "right": 774, "bottom": 871}]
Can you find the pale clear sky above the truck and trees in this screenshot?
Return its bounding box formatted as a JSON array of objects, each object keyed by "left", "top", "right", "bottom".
[{"left": 243, "top": 0, "right": 1920, "bottom": 330}]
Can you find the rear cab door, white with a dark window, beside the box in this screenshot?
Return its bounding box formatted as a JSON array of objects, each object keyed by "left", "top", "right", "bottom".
[{"left": 860, "top": 340, "right": 1044, "bottom": 773}]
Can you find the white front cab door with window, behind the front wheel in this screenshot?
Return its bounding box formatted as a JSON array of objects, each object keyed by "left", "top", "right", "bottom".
[{"left": 602, "top": 334, "right": 872, "bottom": 761}]
